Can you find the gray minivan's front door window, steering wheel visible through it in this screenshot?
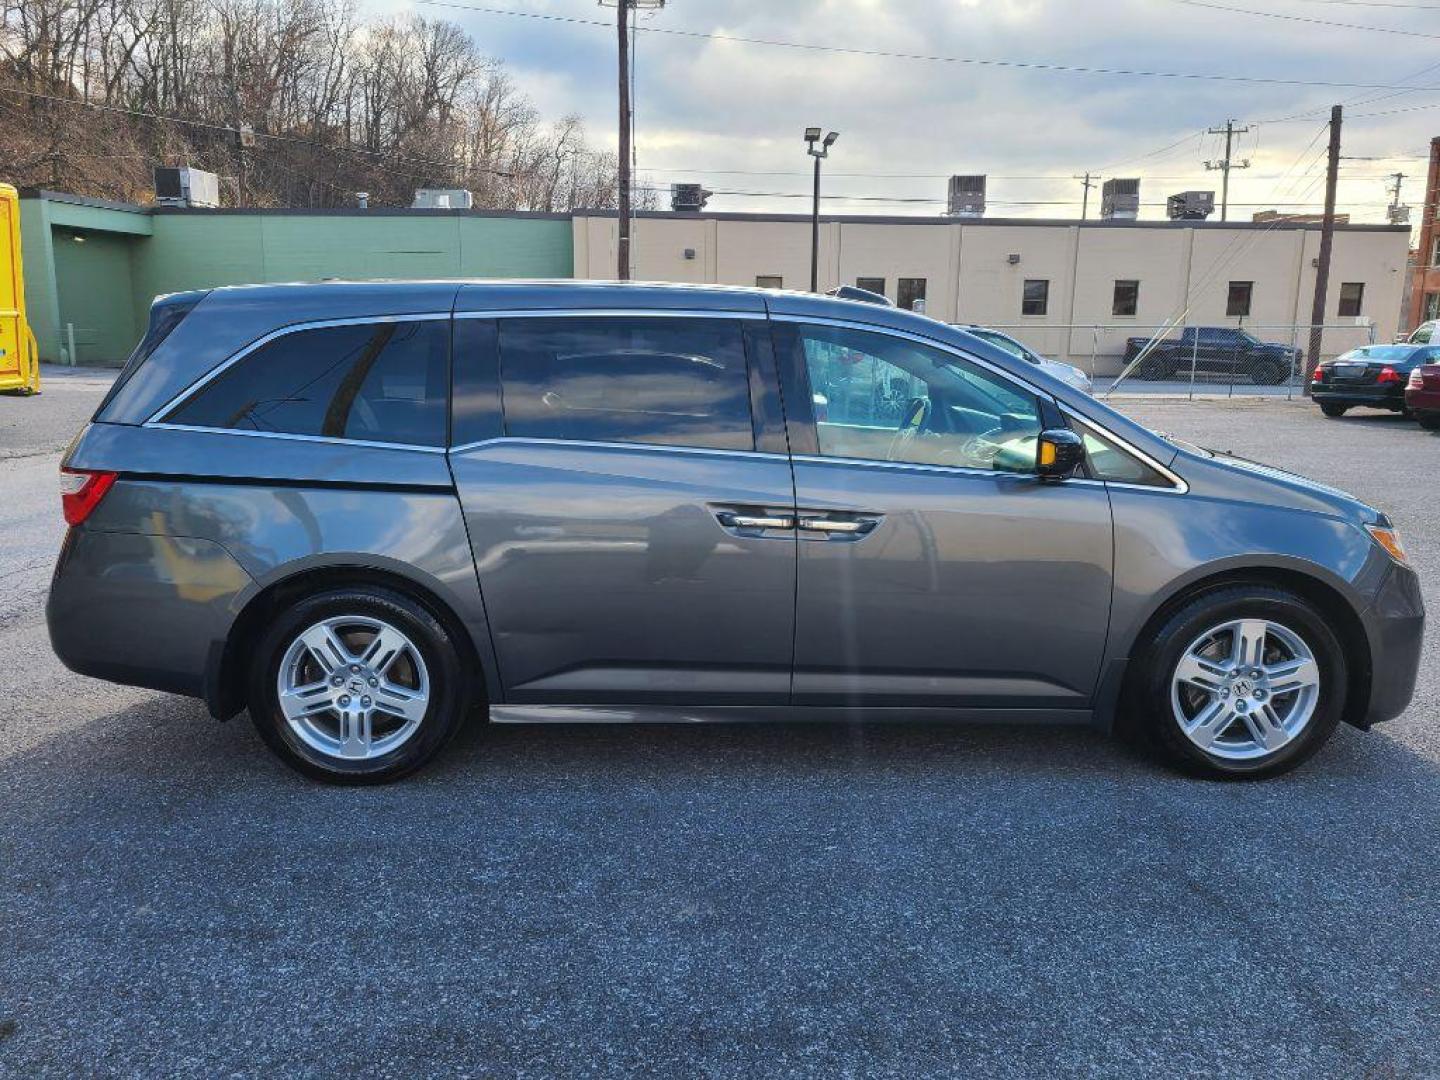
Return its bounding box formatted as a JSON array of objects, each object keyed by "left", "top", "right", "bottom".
[{"left": 799, "top": 327, "right": 1041, "bottom": 472}]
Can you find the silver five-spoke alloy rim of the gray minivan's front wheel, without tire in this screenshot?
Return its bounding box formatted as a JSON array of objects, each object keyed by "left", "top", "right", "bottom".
[{"left": 1171, "top": 619, "right": 1320, "bottom": 760}]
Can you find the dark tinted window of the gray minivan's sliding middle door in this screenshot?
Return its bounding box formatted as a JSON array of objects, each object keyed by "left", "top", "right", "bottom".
[{"left": 500, "top": 318, "right": 755, "bottom": 451}]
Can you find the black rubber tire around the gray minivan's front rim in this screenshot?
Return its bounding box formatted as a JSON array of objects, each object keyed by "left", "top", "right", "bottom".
[{"left": 1126, "top": 583, "right": 1348, "bottom": 780}]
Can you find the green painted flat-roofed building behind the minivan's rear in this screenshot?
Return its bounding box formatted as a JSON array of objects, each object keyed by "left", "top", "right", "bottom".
[{"left": 20, "top": 190, "right": 575, "bottom": 364}]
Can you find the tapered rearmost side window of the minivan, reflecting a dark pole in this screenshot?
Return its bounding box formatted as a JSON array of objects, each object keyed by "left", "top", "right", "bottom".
[{"left": 166, "top": 320, "right": 451, "bottom": 446}]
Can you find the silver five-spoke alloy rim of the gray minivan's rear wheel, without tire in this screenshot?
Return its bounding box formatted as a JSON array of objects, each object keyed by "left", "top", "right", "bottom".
[{"left": 275, "top": 615, "right": 431, "bottom": 760}]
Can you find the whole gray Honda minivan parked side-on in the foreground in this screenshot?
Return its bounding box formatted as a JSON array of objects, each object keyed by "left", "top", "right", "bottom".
[{"left": 48, "top": 282, "right": 1424, "bottom": 780}]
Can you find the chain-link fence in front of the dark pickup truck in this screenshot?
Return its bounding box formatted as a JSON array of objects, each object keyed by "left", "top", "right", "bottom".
[{"left": 967, "top": 328, "right": 1378, "bottom": 399}]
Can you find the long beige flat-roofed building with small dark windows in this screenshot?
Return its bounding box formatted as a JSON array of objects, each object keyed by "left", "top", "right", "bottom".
[{"left": 573, "top": 212, "right": 1410, "bottom": 372}]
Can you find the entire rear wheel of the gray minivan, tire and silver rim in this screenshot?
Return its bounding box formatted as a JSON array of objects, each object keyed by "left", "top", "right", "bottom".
[{"left": 249, "top": 588, "right": 467, "bottom": 783}]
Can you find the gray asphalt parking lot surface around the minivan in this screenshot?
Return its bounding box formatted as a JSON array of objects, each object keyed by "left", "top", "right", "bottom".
[{"left": 0, "top": 374, "right": 1440, "bottom": 1077}]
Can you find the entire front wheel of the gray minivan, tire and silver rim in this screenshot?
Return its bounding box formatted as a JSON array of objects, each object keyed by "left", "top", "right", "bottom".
[{"left": 1130, "top": 585, "right": 1346, "bottom": 779}]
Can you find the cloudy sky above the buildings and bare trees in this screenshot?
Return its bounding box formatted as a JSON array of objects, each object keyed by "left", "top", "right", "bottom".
[{"left": 405, "top": 0, "right": 1440, "bottom": 220}]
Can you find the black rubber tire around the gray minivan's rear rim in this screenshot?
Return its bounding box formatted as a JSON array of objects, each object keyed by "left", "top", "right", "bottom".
[{"left": 249, "top": 586, "right": 471, "bottom": 783}]
